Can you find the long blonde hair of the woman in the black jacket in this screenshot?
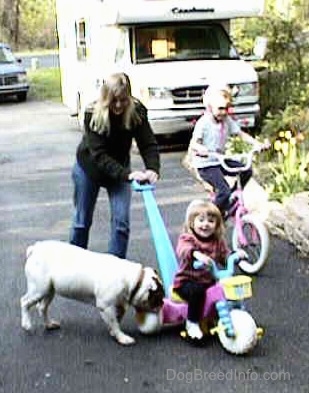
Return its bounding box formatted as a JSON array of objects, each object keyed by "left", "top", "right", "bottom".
[{"left": 90, "top": 73, "right": 141, "bottom": 134}]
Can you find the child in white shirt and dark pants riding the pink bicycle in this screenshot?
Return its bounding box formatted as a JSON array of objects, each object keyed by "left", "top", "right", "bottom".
[{"left": 189, "top": 86, "right": 265, "bottom": 217}]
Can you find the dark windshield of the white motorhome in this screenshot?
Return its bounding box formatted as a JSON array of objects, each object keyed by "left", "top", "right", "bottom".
[{"left": 133, "top": 24, "right": 239, "bottom": 63}]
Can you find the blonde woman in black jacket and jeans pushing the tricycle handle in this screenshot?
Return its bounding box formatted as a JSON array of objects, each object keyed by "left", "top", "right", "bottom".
[{"left": 70, "top": 73, "right": 160, "bottom": 258}]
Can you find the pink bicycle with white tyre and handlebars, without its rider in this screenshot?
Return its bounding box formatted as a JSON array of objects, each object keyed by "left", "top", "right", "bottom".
[{"left": 203, "top": 149, "right": 269, "bottom": 274}]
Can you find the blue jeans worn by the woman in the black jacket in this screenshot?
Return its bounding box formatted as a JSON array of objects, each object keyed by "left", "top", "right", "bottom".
[{"left": 70, "top": 163, "right": 132, "bottom": 258}]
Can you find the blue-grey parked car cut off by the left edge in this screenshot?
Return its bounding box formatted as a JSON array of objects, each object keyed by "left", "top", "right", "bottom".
[{"left": 0, "top": 43, "right": 29, "bottom": 102}]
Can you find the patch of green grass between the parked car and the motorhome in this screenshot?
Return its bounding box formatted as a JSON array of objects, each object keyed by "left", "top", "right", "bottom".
[{"left": 28, "top": 68, "right": 61, "bottom": 102}]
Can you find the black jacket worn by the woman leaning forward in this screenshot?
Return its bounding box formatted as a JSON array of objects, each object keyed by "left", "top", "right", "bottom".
[{"left": 77, "top": 100, "right": 160, "bottom": 186}]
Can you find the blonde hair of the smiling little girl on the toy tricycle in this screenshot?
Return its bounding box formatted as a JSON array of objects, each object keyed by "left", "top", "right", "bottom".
[{"left": 184, "top": 199, "right": 225, "bottom": 240}]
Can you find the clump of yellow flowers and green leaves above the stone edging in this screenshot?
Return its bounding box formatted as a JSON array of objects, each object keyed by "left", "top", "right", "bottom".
[{"left": 259, "top": 105, "right": 309, "bottom": 202}]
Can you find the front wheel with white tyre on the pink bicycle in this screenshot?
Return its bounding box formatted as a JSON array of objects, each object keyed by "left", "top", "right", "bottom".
[{"left": 232, "top": 214, "right": 269, "bottom": 274}]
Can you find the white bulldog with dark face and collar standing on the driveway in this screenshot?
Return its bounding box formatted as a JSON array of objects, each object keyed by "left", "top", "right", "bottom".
[{"left": 20, "top": 240, "right": 164, "bottom": 345}]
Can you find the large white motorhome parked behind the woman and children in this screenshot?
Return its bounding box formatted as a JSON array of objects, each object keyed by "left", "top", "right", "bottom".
[{"left": 56, "top": 0, "right": 264, "bottom": 134}]
